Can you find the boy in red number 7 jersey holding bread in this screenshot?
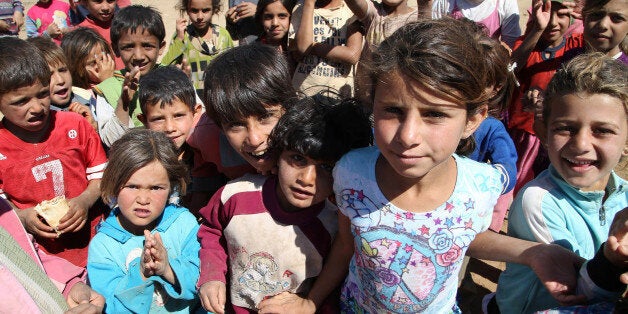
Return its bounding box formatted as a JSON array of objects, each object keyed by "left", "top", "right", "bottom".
[{"left": 0, "top": 37, "right": 107, "bottom": 267}]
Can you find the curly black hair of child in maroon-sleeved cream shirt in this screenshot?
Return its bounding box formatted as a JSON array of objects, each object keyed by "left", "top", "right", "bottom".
[{"left": 269, "top": 97, "right": 373, "bottom": 162}]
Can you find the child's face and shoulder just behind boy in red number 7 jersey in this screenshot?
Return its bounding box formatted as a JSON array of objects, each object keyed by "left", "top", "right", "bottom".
[{"left": 29, "top": 37, "right": 97, "bottom": 130}]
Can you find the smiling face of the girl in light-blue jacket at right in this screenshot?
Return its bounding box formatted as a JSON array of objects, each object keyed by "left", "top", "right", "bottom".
[{"left": 543, "top": 94, "right": 628, "bottom": 191}]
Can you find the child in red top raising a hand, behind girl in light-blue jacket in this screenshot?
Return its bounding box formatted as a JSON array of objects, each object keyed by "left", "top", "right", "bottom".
[{"left": 508, "top": 0, "right": 584, "bottom": 194}]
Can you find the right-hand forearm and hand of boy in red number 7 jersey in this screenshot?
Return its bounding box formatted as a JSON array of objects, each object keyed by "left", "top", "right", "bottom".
[{"left": 57, "top": 179, "right": 100, "bottom": 233}]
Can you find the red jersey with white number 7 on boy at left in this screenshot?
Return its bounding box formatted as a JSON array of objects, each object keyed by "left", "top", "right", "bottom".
[{"left": 0, "top": 111, "right": 107, "bottom": 266}]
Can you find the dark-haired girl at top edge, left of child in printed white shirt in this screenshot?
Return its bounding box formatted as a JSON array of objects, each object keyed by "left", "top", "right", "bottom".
[{"left": 255, "top": 0, "right": 295, "bottom": 52}]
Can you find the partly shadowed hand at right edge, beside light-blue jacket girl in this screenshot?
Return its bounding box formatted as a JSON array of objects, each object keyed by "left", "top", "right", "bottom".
[{"left": 604, "top": 207, "right": 628, "bottom": 269}]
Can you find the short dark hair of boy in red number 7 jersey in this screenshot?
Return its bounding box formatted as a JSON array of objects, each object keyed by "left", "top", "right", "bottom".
[{"left": 0, "top": 36, "right": 50, "bottom": 96}]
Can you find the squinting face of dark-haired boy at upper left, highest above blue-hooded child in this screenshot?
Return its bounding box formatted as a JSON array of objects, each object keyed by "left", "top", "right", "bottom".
[{"left": 116, "top": 27, "right": 166, "bottom": 76}]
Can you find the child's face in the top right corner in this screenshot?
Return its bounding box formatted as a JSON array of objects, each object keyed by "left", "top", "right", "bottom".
[{"left": 584, "top": 0, "right": 628, "bottom": 56}]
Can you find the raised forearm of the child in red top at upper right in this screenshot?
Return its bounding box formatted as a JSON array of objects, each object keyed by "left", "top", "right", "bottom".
[{"left": 511, "top": 0, "right": 552, "bottom": 71}]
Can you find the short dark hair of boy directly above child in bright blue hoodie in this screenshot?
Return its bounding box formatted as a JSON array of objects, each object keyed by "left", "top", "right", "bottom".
[{"left": 138, "top": 66, "right": 196, "bottom": 114}]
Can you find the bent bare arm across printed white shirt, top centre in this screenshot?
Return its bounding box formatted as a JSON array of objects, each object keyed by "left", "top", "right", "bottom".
[{"left": 311, "top": 22, "right": 364, "bottom": 64}]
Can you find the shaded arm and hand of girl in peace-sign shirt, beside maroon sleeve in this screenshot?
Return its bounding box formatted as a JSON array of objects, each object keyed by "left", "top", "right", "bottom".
[{"left": 258, "top": 213, "right": 354, "bottom": 313}]
